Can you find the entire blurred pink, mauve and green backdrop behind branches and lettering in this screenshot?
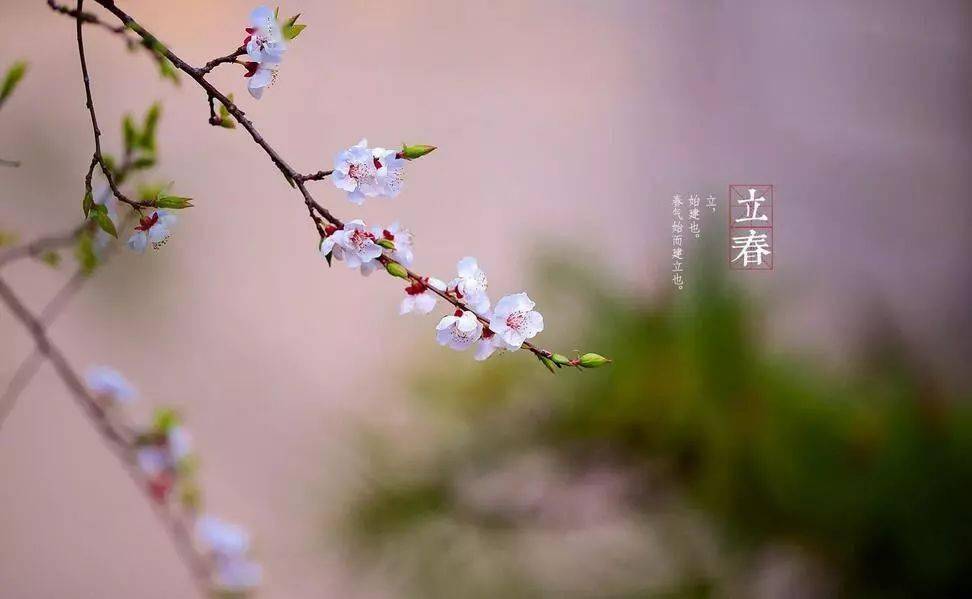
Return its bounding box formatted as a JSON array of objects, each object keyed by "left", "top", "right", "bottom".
[{"left": 0, "top": 0, "right": 972, "bottom": 598}]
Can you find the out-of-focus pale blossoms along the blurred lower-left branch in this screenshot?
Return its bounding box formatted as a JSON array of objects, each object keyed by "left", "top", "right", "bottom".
[{"left": 86, "top": 366, "right": 262, "bottom": 593}]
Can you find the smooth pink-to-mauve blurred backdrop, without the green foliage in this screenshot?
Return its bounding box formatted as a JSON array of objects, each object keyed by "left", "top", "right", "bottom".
[{"left": 0, "top": 0, "right": 972, "bottom": 598}]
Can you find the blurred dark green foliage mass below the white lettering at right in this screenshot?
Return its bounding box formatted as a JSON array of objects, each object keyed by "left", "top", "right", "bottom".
[{"left": 347, "top": 254, "right": 972, "bottom": 597}]
